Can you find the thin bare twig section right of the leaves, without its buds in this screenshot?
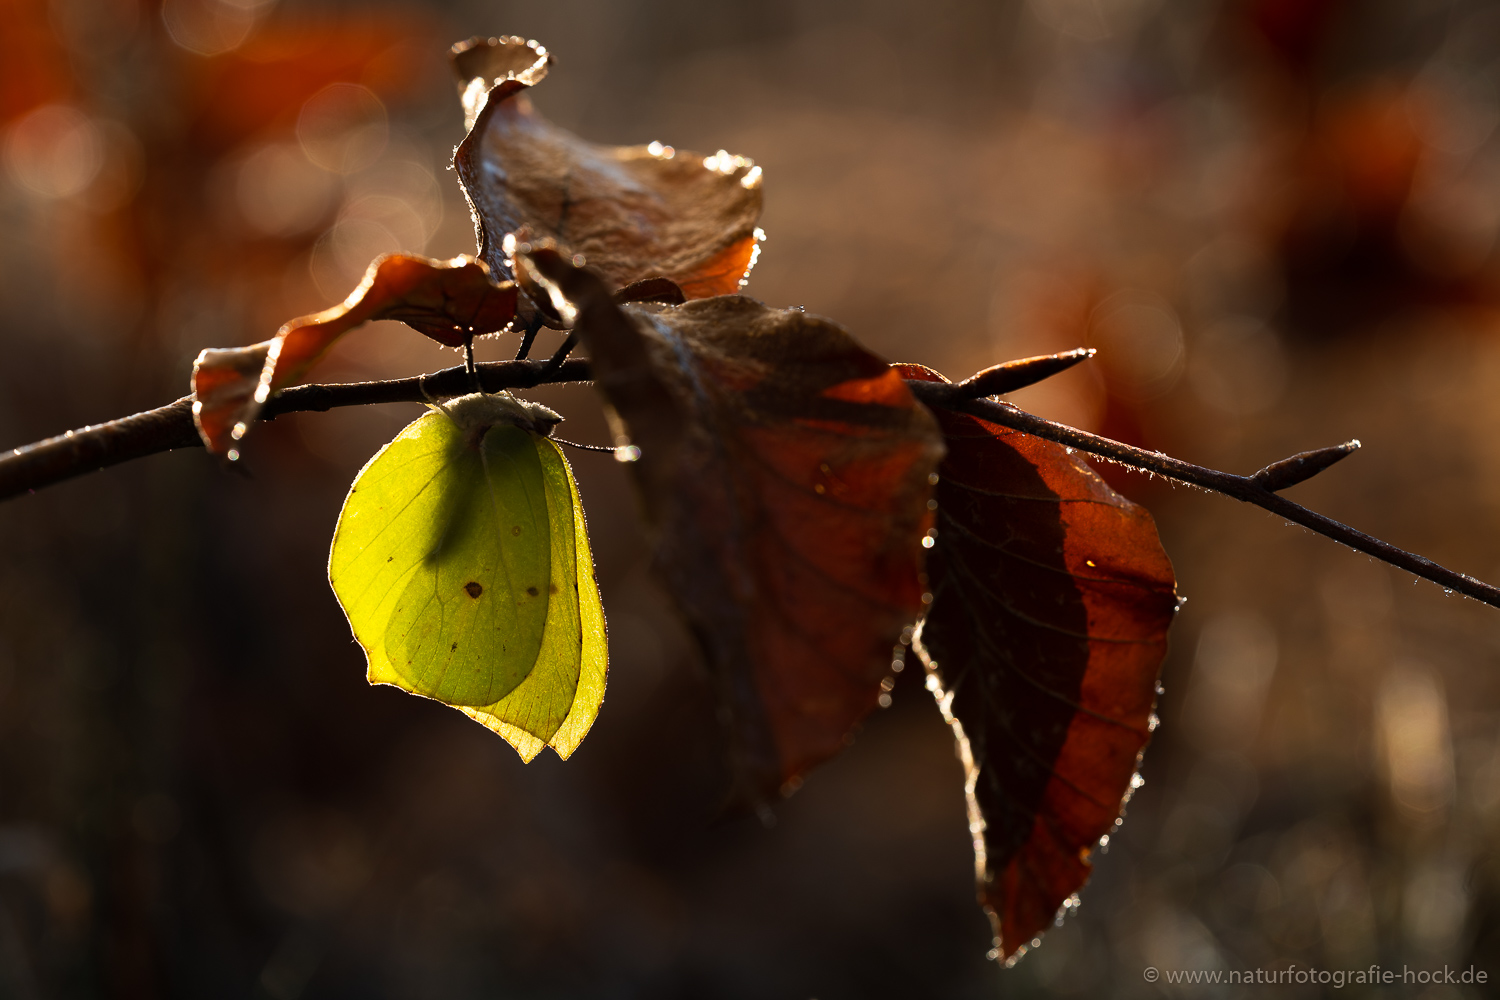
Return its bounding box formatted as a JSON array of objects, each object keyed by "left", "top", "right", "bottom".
[{"left": 908, "top": 381, "right": 1500, "bottom": 607}]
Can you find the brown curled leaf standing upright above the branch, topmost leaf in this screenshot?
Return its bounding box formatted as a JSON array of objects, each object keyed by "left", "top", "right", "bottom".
[{"left": 453, "top": 37, "right": 761, "bottom": 305}]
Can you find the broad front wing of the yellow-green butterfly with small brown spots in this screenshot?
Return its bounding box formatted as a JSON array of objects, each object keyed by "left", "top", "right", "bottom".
[{"left": 329, "top": 412, "right": 552, "bottom": 706}]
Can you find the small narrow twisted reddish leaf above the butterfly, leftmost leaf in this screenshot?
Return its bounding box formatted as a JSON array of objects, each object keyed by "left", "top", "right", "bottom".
[{"left": 192, "top": 253, "right": 516, "bottom": 459}]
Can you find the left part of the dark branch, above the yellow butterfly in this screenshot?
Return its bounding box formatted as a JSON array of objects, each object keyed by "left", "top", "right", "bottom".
[{"left": 0, "top": 360, "right": 588, "bottom": 501}]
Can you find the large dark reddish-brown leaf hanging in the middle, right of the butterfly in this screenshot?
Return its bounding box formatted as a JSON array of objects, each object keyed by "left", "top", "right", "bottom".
[{"left": 527, "top": 250, "right": 942, "bottom": 804}]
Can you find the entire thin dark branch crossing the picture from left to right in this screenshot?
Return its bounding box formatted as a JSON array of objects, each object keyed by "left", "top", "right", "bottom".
[{"left": 0, "top": 355, "right": 1500, "bottom": 607}]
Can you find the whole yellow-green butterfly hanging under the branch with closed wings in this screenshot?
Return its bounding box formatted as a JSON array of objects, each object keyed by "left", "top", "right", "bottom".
[{"left": 329, "top": 394, "right": 608, "bottom": 760}]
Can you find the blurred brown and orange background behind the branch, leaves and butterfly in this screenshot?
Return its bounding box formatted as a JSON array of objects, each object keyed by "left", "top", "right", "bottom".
[{"left": 0, "top": 0, "right": 1500, "bottom": 1000}]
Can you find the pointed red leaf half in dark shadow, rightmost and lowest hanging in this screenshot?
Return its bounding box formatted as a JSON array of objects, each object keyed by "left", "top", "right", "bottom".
[{"left": 900, "top": 364, "right": 1178, "bottom": 961}]
